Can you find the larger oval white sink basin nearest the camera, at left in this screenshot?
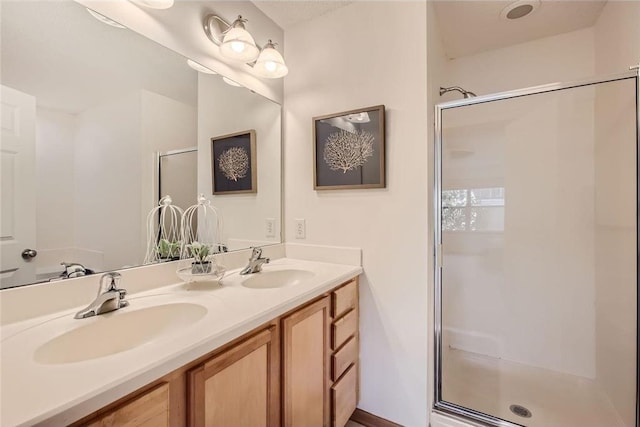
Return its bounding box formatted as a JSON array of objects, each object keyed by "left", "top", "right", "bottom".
[{"left": 34, "top": 302, "right": 207, "bottom": 365}]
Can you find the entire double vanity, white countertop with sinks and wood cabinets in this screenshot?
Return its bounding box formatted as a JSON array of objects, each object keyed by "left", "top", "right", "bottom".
[{"left": 0, "top": 245, "right": 362, "bottom": 427}]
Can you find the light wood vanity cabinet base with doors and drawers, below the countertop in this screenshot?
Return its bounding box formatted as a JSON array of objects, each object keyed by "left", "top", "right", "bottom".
[{"left": 73, "top": 279, "right": 358, "bottom": 427}]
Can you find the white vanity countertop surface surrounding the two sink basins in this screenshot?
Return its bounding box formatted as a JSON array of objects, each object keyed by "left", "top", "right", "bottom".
[{"left": 0, "top": 258, "right": 362, "bottom": 427}]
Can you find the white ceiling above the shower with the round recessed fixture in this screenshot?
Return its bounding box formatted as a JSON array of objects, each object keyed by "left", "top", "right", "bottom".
[{"left": 433, "top": 0, "right": 607, "bottom": 59}]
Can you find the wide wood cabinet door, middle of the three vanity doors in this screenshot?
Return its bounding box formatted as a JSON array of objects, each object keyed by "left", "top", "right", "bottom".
[{"left": 188, "top": 326, "right": 280, "bottom": 427}]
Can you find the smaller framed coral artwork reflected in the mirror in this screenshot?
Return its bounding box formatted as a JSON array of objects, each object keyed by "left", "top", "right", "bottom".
[{"left": 211, "top": 130, "right": 258, "bottom": 194}]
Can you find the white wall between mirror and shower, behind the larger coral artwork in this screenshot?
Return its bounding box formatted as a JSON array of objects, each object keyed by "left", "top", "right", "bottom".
[{"left": 284, "top": 1, "right": 430, "bottom": 426}]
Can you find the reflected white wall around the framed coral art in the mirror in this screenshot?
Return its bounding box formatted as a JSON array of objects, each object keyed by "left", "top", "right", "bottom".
[{"left": 198, "top": 74, "right": 282, "bottom": 250}]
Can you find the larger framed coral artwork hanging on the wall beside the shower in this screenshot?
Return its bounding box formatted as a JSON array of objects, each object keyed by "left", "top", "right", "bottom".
[{"left": 313, "top": 105, "right": 386, "bottom": 190}]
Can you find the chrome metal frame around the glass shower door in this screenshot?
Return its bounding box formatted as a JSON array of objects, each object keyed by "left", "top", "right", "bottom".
[{"left": 432, "top": 67, "right": 640, "bottom": 427}]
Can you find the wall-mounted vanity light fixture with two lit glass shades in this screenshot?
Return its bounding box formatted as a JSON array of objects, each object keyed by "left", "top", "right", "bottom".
[{"left": 204, "top": 14, "right": 289, "bottom": 78}]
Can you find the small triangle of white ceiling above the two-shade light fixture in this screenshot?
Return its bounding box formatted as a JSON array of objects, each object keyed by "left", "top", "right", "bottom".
[{"left": 252, "top": 0, "right": 353, "bottom": 30}]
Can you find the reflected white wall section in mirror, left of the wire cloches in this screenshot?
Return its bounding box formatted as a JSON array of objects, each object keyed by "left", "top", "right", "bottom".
[{"left": 75, "top": 93, "right": 144, "bottom": 270}]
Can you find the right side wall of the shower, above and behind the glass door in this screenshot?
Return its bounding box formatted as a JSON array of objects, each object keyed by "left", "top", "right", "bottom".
[{"left": 595, "top": 1, "right": 640, "bottom": 426}]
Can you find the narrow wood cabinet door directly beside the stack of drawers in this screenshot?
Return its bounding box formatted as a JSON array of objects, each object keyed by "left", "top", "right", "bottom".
[{"left": 282, "top": 296, "right": 331, "bottom": 427}]
